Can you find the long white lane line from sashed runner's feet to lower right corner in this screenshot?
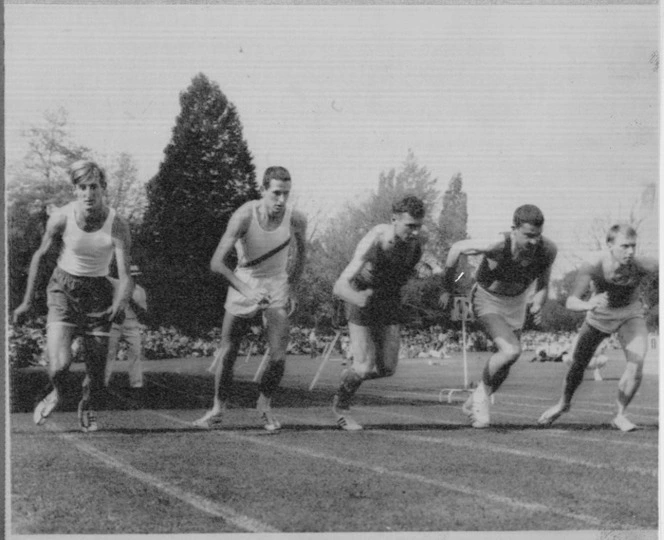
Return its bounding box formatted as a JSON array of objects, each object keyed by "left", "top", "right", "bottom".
[{"left": 152, "top": 410, "right": 625, "bottom": 528}]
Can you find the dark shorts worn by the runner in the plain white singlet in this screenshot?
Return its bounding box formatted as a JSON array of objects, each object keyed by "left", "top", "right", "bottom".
[{"left": 46, "top": 267, "right": 122, "bottom": 335}]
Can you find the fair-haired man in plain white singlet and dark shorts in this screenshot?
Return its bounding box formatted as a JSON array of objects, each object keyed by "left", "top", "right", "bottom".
[{"left": 13, "top": 161, "right": 133, "bottom": 432}]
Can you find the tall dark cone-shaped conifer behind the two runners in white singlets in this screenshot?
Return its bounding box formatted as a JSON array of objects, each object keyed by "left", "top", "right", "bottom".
[{"left": 136, "top": 74, "right": 259, "bottom": 332}]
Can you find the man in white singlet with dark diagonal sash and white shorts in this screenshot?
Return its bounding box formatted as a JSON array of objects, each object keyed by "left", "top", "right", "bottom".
[{"left": 194, "top": 167, "right": 306, "bottom": 431}]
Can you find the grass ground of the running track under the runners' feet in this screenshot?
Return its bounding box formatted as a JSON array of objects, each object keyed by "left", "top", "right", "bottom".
[{"left": 9, "top": 351, "right": 659, "bottom": 538}]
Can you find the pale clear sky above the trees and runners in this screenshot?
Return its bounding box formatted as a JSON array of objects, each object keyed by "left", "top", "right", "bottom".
[{"left": 5, "top": 4, "right": 659, "bottom": 274}]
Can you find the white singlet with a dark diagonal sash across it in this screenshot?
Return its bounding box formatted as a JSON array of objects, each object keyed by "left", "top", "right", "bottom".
[{"left": 235, "top": 201, "right": 292, "bottom": 278}]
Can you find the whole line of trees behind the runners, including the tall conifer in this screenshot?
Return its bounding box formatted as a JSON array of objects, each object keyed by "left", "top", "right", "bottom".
[{"left": 6, "top": 74, "right": 659, "bottom": 335}]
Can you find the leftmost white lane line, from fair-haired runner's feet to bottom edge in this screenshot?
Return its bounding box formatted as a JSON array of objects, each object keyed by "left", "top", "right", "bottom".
[{"left": 45, "top": 420, "right": 280, "bottom": 533}]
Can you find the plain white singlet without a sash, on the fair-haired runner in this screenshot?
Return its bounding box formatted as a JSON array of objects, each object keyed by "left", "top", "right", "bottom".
[{"left": 58, "top": 203, "right": 115, "bottom": 277}]
